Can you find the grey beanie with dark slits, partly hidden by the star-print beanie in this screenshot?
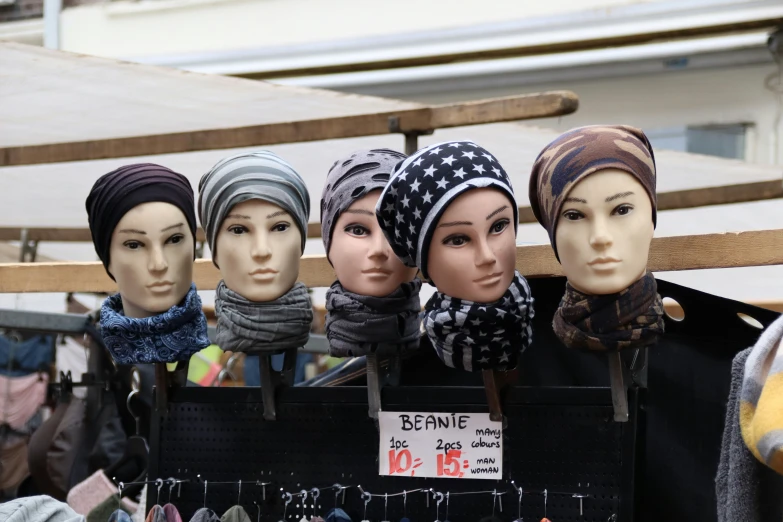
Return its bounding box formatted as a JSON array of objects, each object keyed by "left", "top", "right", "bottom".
[{"left": 321, "top": 149, "right": 407, "bottom": 262}]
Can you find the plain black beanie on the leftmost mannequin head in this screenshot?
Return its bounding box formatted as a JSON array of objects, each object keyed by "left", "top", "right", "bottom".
[{"left": 86, "top": 163, "right": 196, "bottom": 279}]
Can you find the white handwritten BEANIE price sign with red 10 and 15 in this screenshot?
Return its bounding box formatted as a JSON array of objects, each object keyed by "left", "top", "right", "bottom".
[{"left": 378, "top": 411, "right": 503, "bottom": 480}]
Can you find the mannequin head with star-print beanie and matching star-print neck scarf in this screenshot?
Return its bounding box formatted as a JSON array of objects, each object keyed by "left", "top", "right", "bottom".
[{"left": 375, "top": 141, "right": 533, "bottom": 371}]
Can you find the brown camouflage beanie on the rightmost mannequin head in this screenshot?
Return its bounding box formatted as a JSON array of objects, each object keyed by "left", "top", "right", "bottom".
[{"left": 529, "top": 125, "right": 657, "bottom": 261}]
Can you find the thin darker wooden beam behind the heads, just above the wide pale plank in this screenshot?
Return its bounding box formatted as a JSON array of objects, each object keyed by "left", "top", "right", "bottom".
[{"left": 0, "top": 181, "right": 783, "bottom": 242}]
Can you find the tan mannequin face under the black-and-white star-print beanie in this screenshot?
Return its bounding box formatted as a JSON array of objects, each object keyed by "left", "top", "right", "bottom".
[{"left": 428, "top": 188, "right": 516, "bottom": 303}]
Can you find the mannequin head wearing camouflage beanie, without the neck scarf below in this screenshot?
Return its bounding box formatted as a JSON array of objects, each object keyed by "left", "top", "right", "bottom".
[{"left": 530, "top": 122, "right": 656, "bottom": 295}]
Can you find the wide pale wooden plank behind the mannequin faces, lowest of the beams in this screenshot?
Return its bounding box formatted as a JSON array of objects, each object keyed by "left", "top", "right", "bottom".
[{"left": 0, "top": 229, "right": 783, "bottom": 293}]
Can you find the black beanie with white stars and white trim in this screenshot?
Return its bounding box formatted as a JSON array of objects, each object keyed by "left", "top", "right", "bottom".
[{"left": 375, "top": 141, "right": 519, "bottom": 279}]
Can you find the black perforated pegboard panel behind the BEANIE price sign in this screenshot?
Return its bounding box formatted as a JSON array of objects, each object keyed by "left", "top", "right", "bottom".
[{"left": 148, "top": 387, "right": 640, "bottom": 522}]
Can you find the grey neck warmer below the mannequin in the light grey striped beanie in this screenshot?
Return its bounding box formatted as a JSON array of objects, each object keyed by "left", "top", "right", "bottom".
[{"left": 215, "top": 281, "right": 313, "bottom": 353}]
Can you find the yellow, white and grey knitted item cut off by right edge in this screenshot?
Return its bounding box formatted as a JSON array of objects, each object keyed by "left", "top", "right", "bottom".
[{"left": 739, "top": 310, "right": 783, "bottom": 475}]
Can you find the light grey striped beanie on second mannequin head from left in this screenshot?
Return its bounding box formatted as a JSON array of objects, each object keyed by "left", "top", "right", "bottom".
[{"left": 198, "top": 150, "right": 310, "bottom": 266}]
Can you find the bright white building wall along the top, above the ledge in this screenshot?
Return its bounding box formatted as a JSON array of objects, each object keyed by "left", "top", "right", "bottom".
[{"left": 60, "top": 0, "right": 655, "bottom": 57}]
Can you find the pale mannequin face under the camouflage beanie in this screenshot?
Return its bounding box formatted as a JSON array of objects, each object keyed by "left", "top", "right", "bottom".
[{"left": 555, "top": 169, "right": 653, "bottom": 295}]
